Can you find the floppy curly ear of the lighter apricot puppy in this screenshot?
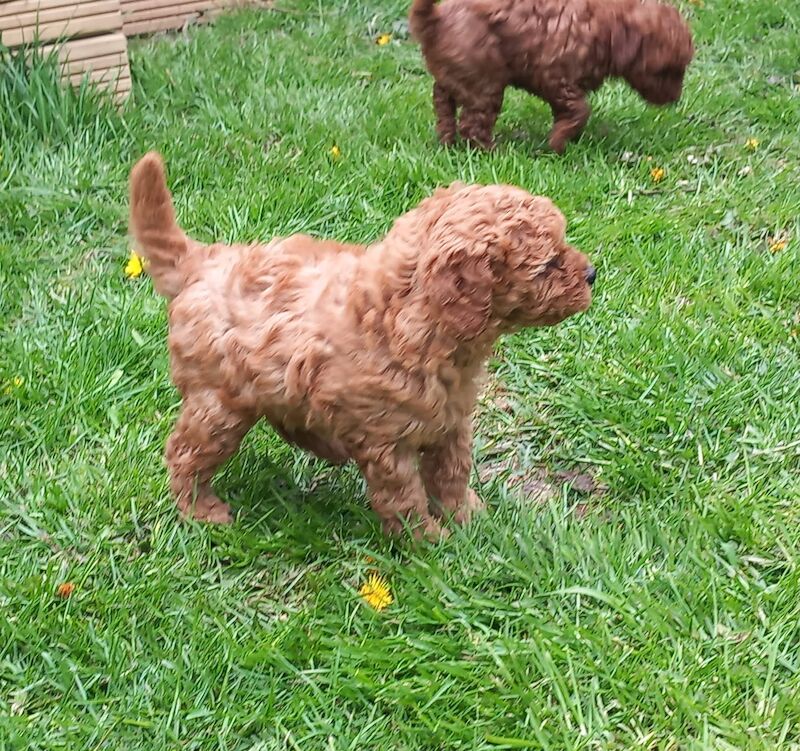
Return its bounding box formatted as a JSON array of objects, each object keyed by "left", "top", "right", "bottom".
[{"left": 423, "top": 246, "right": 494, "bottom": 341}]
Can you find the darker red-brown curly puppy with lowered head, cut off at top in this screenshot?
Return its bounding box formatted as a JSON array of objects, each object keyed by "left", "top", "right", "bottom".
[{"left": 409, "top": 0, "right": 694, "bottom": 153}]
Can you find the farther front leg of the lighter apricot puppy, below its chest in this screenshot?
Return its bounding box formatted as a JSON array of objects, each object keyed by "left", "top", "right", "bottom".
[{"left": 420, "top": 419, "right": 485, "bottom": 524}]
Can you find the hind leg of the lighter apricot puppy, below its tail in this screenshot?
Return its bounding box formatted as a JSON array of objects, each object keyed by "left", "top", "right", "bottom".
[{"left": 166, "top": 391, "right": 255, "bottom": 524}]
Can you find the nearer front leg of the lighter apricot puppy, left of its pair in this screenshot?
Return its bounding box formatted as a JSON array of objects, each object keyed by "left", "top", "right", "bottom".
[{"left": 358, "top": 446, "right": 447, "bottom": 540}]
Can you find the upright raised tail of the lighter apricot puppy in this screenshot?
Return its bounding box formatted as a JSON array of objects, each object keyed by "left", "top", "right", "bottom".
[{"left": 130, "top": 151, "right": 190, "bottom": 300}]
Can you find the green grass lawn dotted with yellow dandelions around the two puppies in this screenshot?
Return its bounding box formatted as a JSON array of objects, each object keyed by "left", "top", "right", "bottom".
[{"left": 0, "top": 0, "right": 800, "bottom": 751}]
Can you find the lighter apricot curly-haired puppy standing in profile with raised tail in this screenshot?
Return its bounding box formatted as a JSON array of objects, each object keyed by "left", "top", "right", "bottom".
[{"left": 131, "top": 153, "right": 594, "bottom": 537}]
